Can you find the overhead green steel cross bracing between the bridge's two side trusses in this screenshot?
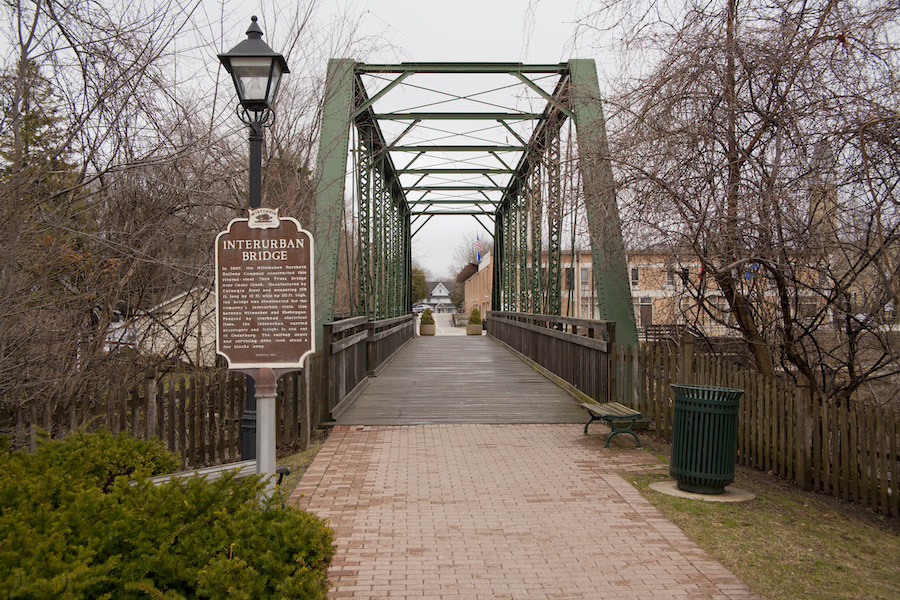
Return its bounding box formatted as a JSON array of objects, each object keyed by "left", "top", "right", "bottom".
[{"left": 354, "top": 63, "right": 568, "bottom": 224}]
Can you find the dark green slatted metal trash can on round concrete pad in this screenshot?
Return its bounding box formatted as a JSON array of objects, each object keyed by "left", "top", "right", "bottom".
[{"left": 669, "top": 384, "right": 744, "bottom": 494}]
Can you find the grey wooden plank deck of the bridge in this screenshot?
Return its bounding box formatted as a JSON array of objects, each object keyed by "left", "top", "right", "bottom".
[{"left": 336, "top": 336, "right": 588, "bottom": 425}]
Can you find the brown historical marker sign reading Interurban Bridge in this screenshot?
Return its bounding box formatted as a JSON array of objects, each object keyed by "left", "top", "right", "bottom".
[{"left": 216, "top": 208, "right": 315, "bottom": 370}]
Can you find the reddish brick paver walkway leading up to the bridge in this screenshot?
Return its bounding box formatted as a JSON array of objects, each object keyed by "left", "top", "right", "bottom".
[{"left": 291, "top": 425, "right": 753, "bottom": 600}]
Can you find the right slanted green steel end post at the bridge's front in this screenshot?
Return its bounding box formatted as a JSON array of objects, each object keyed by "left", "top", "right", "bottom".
[{"left": 569, "top": 59, "right": 637, "bottom": 344}]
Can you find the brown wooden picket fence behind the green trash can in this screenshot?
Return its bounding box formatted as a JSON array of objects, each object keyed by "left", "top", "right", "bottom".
[{"left": 610, "top": 342, "right": 900, "bottom": 517}]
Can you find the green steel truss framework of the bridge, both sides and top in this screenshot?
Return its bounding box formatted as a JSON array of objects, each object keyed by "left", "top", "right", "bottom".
[{"left": 313, "top": 59, "right": 637, "bottom": 343}]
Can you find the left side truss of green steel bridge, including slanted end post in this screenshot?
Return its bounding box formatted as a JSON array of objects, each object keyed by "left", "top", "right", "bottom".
[{"left": 313, "top": 59, "right": 412, "bottom": 342}]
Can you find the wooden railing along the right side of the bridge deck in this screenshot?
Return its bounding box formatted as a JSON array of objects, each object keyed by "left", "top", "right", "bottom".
[{"left": 487, "top": 311, "right": 616, "bottom": 402}]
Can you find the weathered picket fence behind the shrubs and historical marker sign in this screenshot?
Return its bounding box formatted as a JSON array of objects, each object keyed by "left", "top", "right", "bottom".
[{"left": 12, "top": 370, "right": 305, "bottom": 468}]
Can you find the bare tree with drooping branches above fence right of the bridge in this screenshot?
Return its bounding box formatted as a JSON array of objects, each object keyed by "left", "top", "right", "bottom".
[{"left": 587, "top": 0, "right": 900, "bottom": 406}]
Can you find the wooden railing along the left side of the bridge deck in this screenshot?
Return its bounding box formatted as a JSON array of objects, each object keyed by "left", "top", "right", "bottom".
[{"left": 319, "top": 315, "right": 415, "bottom": 420}]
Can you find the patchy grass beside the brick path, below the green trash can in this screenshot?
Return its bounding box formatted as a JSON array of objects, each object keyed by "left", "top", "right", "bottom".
[{"left": 626, "top": 438, "right": 900, "bottom": 600}]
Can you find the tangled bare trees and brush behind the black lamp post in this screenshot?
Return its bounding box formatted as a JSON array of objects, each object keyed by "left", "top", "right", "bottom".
[{"left": 0, "top": 0, "right": 330, "bottom": 434}]
